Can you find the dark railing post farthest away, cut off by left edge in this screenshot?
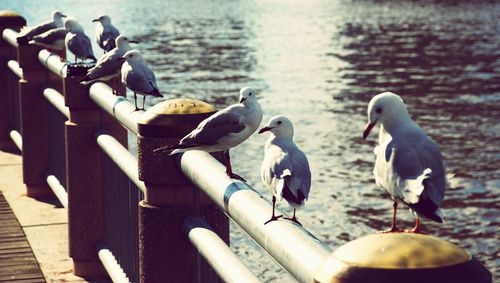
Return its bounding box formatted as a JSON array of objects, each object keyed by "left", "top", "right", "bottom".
[{"left": 0, "top": 11, "right": 26, "bottom": 150}]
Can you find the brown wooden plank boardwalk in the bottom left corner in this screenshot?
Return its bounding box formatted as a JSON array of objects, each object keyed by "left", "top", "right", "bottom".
[{"left": 0, "top": 192, "right": 46, "bottom": 283}]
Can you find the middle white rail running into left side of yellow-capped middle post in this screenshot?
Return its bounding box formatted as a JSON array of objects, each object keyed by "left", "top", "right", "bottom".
[{"left": 97, "top": 133, "right": 146, "bottom": 193}]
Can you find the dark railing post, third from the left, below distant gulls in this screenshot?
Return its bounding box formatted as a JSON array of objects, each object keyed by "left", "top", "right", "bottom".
[{"left": 63, "top": 68, "right": 106, "bottom": 277}]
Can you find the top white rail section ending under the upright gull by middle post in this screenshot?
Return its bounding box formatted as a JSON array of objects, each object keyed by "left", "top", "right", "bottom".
[{"left": 90, "top": 82, "right": 142, "bottom": 134}]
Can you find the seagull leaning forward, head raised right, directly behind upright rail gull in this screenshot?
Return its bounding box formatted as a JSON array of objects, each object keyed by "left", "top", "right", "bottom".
[{"left": 80, "top": 35, "right": 138, "bottom": 91}]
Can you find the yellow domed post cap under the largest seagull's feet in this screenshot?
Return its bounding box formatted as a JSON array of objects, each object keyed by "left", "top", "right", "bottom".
[{"left": 315, "top": 233, "right": 491, "bottom": 283}]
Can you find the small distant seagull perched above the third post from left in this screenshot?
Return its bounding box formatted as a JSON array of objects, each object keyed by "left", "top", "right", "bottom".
[{"left": 64, "top": 18, "right": 97, "bottom": 63}]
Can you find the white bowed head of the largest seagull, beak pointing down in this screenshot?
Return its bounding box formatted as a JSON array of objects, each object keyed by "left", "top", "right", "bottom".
[{"left": 363, "top": 92, "right": 408, "bottom": 139}]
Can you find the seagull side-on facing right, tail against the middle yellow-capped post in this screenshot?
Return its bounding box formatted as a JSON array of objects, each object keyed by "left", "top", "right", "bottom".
[{"left": 154, "top": 87, "right": 262, "bottom": 182}]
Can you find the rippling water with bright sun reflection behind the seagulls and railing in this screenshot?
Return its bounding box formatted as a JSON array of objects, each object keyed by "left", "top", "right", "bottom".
[{"left": 4, "top": 0, "right": 500, "bottom": 282}]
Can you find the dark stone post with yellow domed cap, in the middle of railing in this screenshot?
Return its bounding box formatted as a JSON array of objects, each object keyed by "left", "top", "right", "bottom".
[{"left": 138, "top": 99, "right": 229, "bottom": 283}]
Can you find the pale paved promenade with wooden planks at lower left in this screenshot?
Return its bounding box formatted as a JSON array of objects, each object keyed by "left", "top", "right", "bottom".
[{"left": 0, "top": 151, "right": 107, "bottom": 283}]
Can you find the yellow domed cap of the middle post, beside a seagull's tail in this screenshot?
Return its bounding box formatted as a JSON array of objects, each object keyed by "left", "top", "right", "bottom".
[{"left": 137, "top": 98, "right": 216, "bottom": 137}]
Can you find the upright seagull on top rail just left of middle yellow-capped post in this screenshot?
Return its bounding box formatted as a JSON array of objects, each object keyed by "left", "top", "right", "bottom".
[{"left": 121, "top": 49, "right": 163, "bottom": 111}]
